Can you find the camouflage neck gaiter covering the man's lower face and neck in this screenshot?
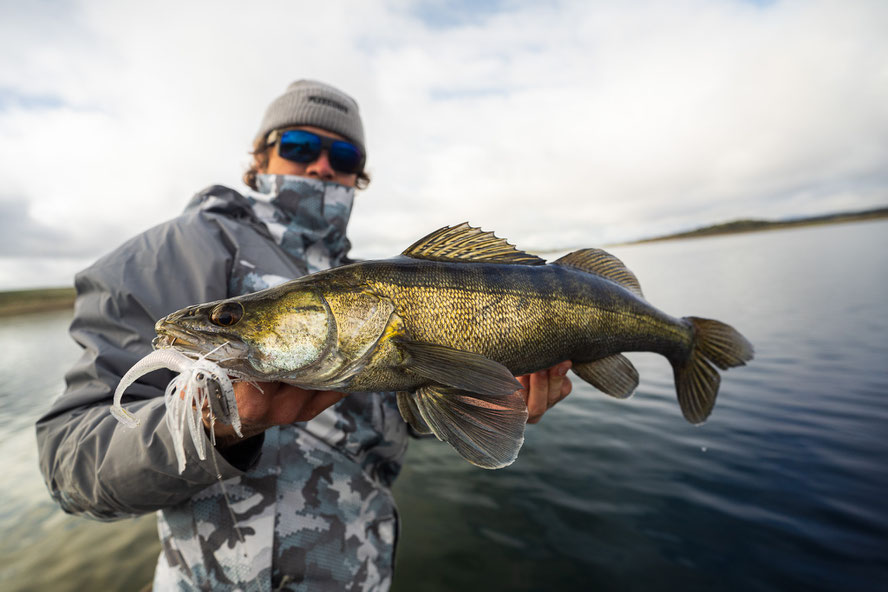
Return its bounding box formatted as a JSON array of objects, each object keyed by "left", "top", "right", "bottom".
[{"left": 247, "top": 175, "right": 355, "bottom": 272}]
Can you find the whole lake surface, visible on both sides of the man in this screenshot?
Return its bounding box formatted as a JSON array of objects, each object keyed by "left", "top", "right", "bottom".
[{"left": 0, "top": 221, "right": 888, "bottom": 592}]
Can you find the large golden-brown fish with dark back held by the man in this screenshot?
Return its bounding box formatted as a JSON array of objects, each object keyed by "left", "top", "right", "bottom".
[{"left": 154, "top": 222, "right": 754, "bottom": 469}]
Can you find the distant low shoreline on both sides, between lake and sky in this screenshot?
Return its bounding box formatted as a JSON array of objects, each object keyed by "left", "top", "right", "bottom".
[{"left": 0, "top": 207, "right": 888, "bottom": 318}]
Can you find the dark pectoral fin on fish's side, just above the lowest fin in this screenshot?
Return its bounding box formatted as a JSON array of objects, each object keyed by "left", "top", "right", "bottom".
[{"left": 398, "top": 340, "right": 522, "bottom": 396}]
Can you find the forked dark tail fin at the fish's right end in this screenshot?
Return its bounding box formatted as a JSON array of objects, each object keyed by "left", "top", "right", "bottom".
[{"left": 672, "top": 317, "right": 753, "bottom": 423}]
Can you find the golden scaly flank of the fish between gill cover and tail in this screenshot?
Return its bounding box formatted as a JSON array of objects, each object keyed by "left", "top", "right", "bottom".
[{"left": 346, "top": 258, "right": 691, "bottom": 375}]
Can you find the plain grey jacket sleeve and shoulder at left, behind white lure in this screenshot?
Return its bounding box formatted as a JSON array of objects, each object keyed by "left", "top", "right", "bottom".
[{"left": 37, "top": 213, "right": 262, "bottom": 520}]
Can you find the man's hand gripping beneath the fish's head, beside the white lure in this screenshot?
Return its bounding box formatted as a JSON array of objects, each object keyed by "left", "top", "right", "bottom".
[{"left": 203, "top": 382, "right": 346, "bottom": 448}]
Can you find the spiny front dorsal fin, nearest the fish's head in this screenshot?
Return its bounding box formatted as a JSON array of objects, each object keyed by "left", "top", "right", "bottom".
[{"left": 402, "top": 222, "right": 546, "bottom": 265}]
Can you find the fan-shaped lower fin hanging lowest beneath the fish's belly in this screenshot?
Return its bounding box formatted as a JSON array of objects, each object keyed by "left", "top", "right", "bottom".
[{"left": 412, "top": 386, "right": 527, "bottom": 469}]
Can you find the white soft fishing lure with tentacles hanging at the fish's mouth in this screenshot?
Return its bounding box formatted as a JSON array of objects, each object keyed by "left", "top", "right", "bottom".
[{"left": 111, "top": 348, "right": 243, "bottom": 473}]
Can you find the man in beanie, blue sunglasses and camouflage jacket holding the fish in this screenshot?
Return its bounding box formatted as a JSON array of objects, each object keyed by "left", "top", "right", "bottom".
[{"left": 37, "top": 80, "right": 570, "bottom": 590}]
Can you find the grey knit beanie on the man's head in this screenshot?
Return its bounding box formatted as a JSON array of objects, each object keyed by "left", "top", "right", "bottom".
[{"left": 256, "top": 80, "right": 367, "bottom": 155}]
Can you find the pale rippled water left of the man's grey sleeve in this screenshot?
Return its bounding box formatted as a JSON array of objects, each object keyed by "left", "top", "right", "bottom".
[{"left": 0, "top": 311, "right": 160, "bottom": 592}]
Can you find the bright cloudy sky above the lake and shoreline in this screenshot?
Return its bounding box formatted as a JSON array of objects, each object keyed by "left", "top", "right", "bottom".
[{"left": 0, "top": 0, "right": 888, "bottom": 290}]
